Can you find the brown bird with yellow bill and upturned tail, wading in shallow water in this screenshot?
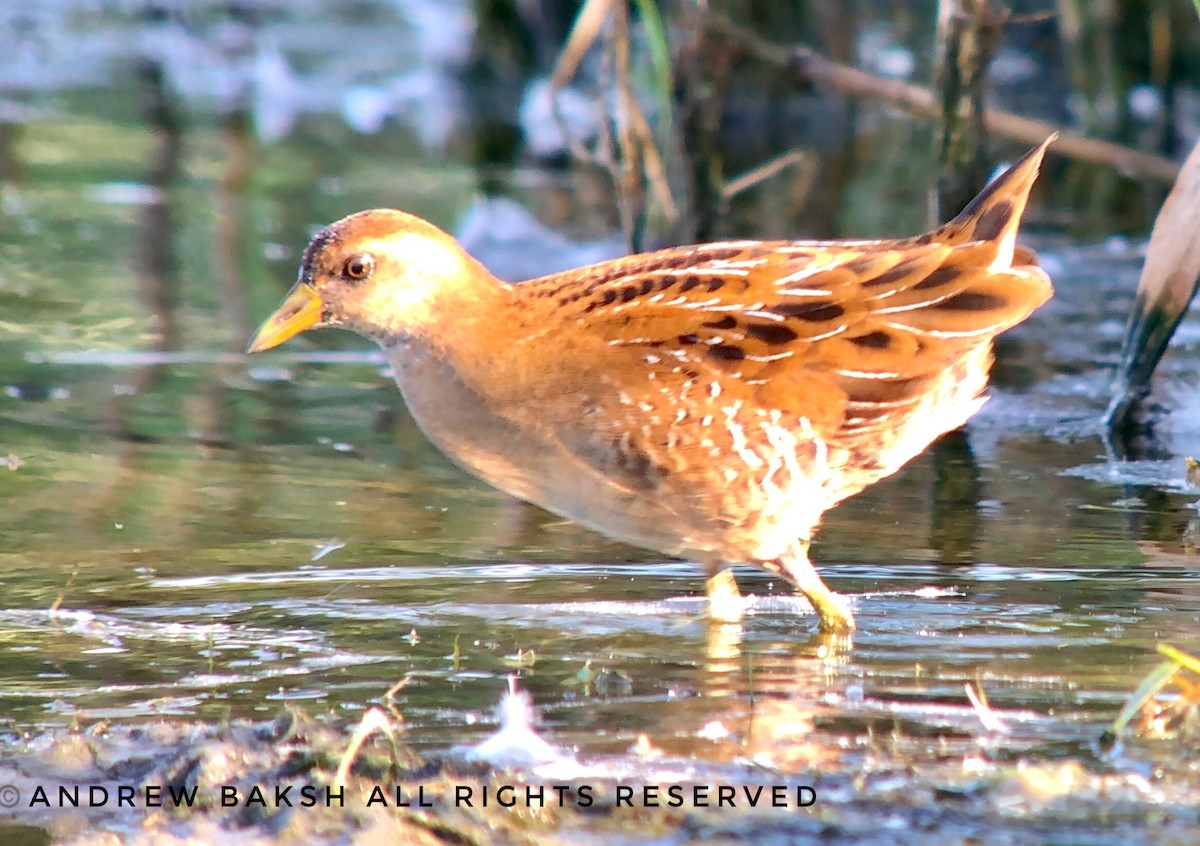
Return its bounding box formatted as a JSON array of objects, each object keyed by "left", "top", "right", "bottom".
[{"left": 247, "top": 137, "right": 1054, "bottom": 638}]
